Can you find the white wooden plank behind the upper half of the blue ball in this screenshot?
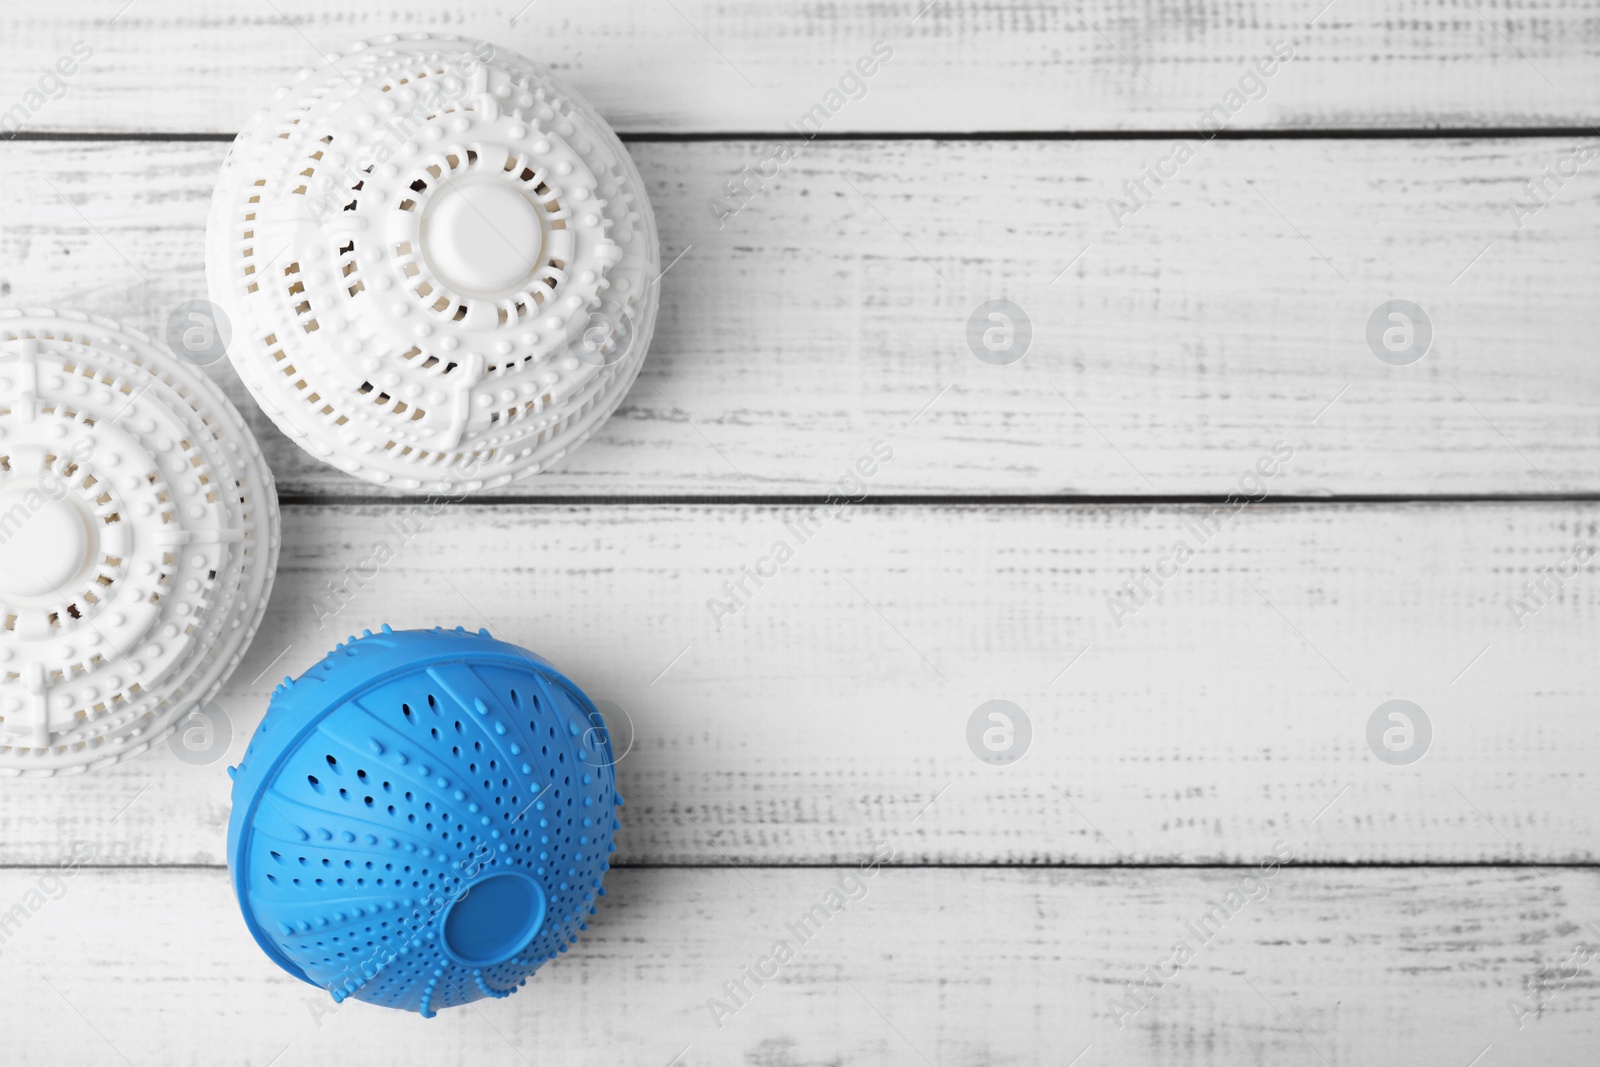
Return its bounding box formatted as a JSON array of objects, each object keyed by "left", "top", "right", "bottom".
[{"left": 0, "top": 504, "right": 1600, "bottom": 865}]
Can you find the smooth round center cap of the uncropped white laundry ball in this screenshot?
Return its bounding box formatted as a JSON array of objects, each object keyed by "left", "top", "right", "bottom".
[{"left": 422, "top": 184, "right": 544, "bottom": 296}]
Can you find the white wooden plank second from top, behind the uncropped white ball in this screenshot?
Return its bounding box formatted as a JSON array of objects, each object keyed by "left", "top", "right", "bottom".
[{"left": 0, "top": 137, "right": 1600, "bottom": 498}]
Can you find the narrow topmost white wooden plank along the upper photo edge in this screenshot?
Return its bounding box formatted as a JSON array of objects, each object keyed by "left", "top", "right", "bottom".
[{"left": 0, "top": 0, "right": 1600, "bottom": 133}]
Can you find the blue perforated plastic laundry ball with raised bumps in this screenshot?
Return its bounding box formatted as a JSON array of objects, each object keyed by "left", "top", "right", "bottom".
[{"left": 227, "top": 625, "right": 622, "bottom": 1016}]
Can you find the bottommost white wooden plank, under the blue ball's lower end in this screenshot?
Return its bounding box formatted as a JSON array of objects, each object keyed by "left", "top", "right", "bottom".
[{"left": 0, "top": 870, "right": 1600, "bottom": 1067}]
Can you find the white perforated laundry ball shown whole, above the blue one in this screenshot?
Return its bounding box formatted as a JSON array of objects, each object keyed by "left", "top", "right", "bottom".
[{"left": 206, "top": 35, "right": 661, "bottom": 491}]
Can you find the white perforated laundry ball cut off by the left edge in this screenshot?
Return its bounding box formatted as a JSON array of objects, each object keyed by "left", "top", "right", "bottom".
[{"left": 0, "top": 310, "right": 278, "bottom": 774}]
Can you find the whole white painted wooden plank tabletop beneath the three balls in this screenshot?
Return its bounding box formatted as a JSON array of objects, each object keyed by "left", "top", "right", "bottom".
[{"left": 0, "top": 0, "right": 1600, "bottom": 1067}]
